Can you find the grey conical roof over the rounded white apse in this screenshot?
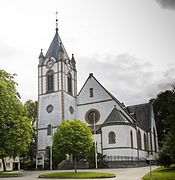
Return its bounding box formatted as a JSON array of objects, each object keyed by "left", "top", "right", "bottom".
[{"left": 103, "top": 107, "right": 128, "bottom": 124}]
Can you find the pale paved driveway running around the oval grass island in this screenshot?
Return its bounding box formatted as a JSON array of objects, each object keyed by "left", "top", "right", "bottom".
[{"left": 5, "top": 166, "right": 156, "bottom": 180}]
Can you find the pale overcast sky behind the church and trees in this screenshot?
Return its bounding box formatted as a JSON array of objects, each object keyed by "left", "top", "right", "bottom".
[{"left": 0, "top": 0, "right": 175, "bottom": 105}]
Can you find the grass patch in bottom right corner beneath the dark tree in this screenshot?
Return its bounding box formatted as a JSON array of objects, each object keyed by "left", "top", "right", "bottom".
[{"left": 142, "top": 165, "right": 175, "bottom": 180}]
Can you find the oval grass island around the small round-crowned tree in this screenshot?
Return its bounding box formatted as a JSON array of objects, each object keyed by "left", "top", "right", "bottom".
[{"left": 39, "top": 172, "right": 115, "bottom": 179}]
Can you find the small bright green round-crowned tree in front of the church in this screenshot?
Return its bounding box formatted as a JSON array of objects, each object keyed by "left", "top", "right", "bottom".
[{"left": 53, "top": 119, "right": 93, "bottom": 172}]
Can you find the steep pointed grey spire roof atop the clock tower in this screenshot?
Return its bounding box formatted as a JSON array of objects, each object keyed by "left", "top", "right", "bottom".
[{"left": 45, "top": 29, "right": 69, "bottom": 60}]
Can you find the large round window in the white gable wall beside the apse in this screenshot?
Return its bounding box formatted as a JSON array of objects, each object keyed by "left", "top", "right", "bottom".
[{"left": 85, "top": 109, "right": 100, "bottom": 124}]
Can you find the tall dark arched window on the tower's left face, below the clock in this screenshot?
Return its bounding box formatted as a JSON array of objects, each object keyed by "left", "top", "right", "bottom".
[{"left": 46, "top": 70, "right": 54, "bottom": 93}]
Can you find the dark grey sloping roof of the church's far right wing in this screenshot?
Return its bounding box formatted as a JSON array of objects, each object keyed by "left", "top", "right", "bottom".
[{"left": 126, "top": 103, "right": 151, "bottom": 131}]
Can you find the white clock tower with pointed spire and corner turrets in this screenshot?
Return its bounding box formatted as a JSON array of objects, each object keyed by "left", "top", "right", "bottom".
[{"left": 37, "top": 19, "right": 77, "bottom": 155}]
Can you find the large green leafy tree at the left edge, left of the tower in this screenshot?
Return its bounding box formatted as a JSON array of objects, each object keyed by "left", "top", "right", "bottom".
[{"left": 0, "top": 70, "right": 32, "bottom": 171}]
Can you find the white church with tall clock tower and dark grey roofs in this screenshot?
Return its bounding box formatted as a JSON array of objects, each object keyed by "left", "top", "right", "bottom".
[{"left": 37, "top": 19, "right": 158, "bottom": 167}]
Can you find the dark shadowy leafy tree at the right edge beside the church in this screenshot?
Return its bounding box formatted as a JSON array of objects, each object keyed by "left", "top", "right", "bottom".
[{"left": 153, "top": 89, "right": 175, "bottom": 166}]
